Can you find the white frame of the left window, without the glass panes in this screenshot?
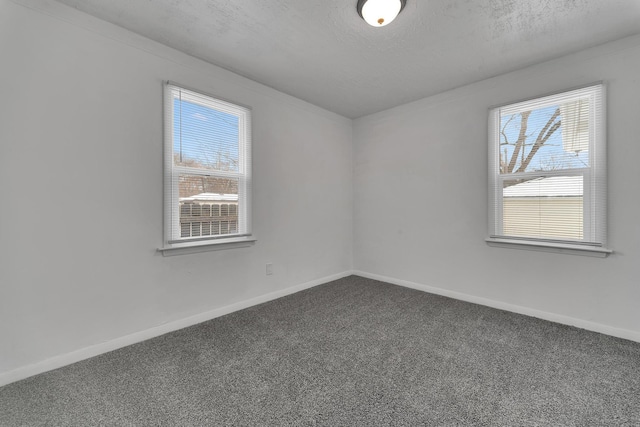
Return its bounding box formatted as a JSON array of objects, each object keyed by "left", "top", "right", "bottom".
[{"left": 159, "top": 82, "right": 256, "bottom": 256}]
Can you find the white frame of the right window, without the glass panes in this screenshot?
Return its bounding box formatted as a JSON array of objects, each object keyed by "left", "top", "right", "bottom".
[{"left": 486, "top": 83, "right": 613, "bottom": 257}]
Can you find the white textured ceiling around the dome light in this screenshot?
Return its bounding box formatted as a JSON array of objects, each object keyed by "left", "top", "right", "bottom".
[{"left": 53, "top": 0, "right": 640, "bottom": 118}]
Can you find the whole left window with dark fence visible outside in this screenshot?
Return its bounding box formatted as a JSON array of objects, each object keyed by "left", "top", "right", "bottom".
[{"left": 162, "top": 83, "right": 253, "bottom": 254}]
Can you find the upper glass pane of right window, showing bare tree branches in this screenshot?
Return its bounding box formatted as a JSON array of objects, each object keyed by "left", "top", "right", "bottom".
[{"left": 498, "top": 98, "right": 591, "bottom": 174}]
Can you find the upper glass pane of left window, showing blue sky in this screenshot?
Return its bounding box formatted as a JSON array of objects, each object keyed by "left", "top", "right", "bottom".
[{"left": 173, "top": 94, "right": 240, "bottom": 172}]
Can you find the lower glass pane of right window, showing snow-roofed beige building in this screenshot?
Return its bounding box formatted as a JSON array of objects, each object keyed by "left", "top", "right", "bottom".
[{"left": 502, "top": 175, "right": 584, "bottom": 240}]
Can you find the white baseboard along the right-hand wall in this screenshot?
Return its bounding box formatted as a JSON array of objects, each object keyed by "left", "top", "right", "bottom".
[{"left": 353, "top": 271, "right": 640, "bottom": 342}]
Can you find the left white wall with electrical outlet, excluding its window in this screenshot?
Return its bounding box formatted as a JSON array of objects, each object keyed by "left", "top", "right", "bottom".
[{"left": 0, "top": 0, "right": 352, "bottom": 384}]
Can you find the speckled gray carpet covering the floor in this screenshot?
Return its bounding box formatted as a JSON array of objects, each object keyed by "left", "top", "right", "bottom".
[{"left": 0, "top": 276, "right": 640, "bottom": 426}]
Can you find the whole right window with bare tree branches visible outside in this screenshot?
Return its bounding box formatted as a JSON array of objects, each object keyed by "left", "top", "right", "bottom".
[{"left": 487, "top": 85, "right": 611, "bottom": 256}]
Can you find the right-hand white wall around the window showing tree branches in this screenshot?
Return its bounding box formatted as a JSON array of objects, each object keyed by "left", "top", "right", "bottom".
[{"left": 354, "top": 32, "right": 640, "bottom": 341}]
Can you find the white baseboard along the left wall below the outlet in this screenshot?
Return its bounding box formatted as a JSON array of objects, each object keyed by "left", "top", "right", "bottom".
[{"left": 0, "top": 271, "right": 353, "bottom": 387}]
